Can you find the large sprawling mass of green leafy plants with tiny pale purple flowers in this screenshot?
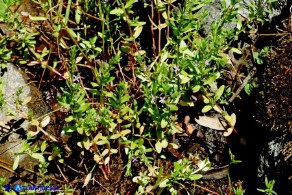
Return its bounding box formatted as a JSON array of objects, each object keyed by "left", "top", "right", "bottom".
[{"left": 0, "top": 0, "right": 278, "bottom": 194}]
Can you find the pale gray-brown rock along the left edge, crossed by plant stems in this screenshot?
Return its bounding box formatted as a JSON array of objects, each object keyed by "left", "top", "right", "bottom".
[{"left": 0, "top": 64, "right": 49, "bottom": 183}]
